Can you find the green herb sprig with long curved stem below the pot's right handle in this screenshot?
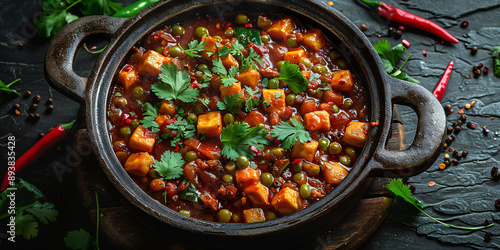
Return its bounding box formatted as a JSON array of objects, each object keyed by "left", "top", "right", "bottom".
[{"left": 386, "top": 179, "right": 493, "bottom": 230}]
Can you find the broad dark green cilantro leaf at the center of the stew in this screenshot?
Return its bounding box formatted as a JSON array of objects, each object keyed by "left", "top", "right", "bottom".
[{"left": 221, "top": 122, "right": 269, "bottom": 161}]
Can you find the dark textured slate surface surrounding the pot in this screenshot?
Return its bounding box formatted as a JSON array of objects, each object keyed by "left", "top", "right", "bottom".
[{"left": 0, "top": 0, "right": 500, "bottom": 249}]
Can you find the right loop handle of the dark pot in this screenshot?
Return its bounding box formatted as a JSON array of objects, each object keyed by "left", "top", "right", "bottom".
[{"left": 372, "top": 77, "right": 446, "bottom": 177}]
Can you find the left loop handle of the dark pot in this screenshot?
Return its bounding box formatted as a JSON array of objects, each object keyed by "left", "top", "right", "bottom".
[{"left": 45, "top": 16, "right": 128, "bottom": 103}]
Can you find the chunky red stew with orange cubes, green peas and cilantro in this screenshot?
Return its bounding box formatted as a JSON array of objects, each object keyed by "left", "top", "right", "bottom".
[{"left": 108, "top": 13, "right": 369, "bottom": 223}]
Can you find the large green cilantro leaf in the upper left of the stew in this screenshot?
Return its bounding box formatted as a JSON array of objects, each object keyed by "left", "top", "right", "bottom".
[{"left": 151, "top": 63, "right": 200, "bottom": 102}]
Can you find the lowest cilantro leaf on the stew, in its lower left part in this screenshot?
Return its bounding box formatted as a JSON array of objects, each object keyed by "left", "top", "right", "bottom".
[{"left": 153, "top": 151, "right": 186, "bottom": 180}]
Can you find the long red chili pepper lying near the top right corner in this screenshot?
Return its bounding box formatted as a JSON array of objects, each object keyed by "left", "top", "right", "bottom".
[{"left": 361, "top": 0, "right": 458, "bottom": 43}]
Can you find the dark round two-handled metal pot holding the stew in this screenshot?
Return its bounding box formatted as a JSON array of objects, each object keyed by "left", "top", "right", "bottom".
[{"left": 45, "top": 0, "right": 446, "bottom": 247}]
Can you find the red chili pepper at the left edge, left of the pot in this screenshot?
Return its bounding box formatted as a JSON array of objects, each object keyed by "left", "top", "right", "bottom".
[{"left": 0, "top": 121, "right": 75, "bottom": 192}]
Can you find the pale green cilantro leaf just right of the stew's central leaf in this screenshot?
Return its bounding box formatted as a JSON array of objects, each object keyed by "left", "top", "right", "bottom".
[{"left": 271, "top": 119, "right": 311, "bottom": 150}]
